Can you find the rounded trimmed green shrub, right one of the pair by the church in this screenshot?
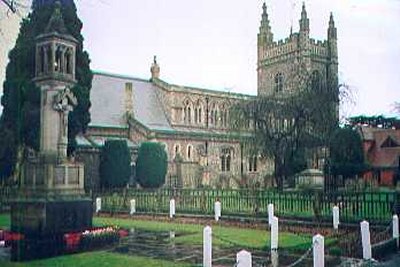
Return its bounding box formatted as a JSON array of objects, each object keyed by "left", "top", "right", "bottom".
[{"left": 136, "top": 142, "right": 168, "bottom": 188}]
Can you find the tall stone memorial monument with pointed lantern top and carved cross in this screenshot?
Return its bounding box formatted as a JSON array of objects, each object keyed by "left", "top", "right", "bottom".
[{"left": 11, "top": 2, "right": 92, "bottom": 262}]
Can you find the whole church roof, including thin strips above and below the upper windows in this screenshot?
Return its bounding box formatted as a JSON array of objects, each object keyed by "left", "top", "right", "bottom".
[{"left": 89, "top": 71, "right": 254, "bottom": 138}]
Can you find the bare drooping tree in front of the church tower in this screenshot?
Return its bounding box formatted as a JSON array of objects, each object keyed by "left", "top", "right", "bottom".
[{"left": 231, "top": 69, "right": 349, "bottom": 191}]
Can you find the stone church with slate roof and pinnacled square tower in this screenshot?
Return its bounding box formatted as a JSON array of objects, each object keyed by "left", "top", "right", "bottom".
[{"left": 77, "top": 3, "right": 338, "bottom": 189}]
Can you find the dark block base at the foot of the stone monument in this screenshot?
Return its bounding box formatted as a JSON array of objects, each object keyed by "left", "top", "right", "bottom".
[{"left": 11, "top": 198, "right": 92, "bottom": 261}]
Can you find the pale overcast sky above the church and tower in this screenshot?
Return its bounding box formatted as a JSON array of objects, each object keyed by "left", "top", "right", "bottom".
[{"left": 0, "top": 0, "right": 400, "bottom": 118}]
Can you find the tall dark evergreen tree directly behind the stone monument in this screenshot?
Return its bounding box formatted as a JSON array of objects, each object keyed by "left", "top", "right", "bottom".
[{"left": 0, "top": 0, "right": 93, "bottom": 181}]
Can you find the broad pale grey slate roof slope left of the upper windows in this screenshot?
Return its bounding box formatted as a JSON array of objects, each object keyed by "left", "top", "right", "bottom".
[{"left": 89, "top": 72, "right": 173, "bottom": 130}]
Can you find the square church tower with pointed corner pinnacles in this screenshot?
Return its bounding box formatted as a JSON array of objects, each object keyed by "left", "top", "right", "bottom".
[{"left": 257, "top": 3, "right": 338, "bottom": 96}]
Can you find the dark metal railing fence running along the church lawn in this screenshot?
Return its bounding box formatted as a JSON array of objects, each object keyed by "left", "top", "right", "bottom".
[{"left": 97, "top": 189, "right": 400, "bottom": 222}]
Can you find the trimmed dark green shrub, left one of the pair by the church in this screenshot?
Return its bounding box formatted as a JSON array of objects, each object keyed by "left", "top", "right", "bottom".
[{"left": 100, "top": 140, "right": 131, "bottom": 188}]
